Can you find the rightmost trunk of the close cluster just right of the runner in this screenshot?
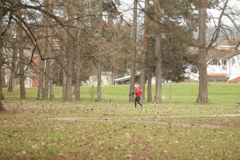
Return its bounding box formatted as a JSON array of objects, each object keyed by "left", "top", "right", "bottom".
[{"left": 154, "top": 0, "right": 162, "bottom": 103}]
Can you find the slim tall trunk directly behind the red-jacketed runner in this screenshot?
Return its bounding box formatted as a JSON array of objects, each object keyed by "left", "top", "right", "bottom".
[{"left": 129, "top": 0, "right": 138, "bottom": 102}]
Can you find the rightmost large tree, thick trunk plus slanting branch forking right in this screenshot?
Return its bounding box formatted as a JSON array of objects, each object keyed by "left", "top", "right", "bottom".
[{"left": 195, "top": 0, "right": 229, "bottom": 103}]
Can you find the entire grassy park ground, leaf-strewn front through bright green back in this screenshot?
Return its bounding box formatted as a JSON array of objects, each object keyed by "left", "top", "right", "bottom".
[{"left": 0, "top": 83, "right": 240, "bottom": 160}]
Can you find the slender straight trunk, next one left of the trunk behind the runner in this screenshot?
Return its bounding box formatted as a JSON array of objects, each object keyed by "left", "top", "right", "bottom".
[{"left": 97, "top": 0, "right": 103, "bottom": 101}]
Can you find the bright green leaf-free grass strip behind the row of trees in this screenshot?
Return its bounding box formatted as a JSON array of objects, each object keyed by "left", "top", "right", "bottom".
[{"left": 3, "top": 83, "right": 240, "bottom": 103}]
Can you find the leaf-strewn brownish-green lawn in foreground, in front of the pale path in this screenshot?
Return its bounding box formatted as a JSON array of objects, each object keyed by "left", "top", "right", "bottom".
[{"left": 0, "top": 104, "right": 240, "bottom": 159}]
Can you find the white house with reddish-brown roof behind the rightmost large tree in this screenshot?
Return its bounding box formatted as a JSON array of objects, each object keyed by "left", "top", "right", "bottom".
[{"left": 189, "top": 39, "right": 240, "bottom": 82}]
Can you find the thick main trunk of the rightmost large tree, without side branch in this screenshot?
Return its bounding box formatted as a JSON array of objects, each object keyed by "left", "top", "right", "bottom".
[{"left": 196, "top": 0, "right": 209, "bottom": 103}]
